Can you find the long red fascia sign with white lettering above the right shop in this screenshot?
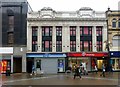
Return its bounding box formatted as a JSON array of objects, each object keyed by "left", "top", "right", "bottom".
[{"left": 67, "top": 52, "right": 108, "bottom": 57}]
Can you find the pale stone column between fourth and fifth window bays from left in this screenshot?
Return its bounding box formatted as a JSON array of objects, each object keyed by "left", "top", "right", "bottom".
[{"left": 76, "top": 26, "right": 80, "bottom": 52}]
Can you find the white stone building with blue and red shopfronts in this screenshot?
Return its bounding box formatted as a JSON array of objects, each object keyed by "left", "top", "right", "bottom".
[{"left": 26, "top": 7, "right": 108, "bottom": 73}]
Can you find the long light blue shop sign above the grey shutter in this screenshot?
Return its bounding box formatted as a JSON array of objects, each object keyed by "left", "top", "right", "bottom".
[{"left": 26, "top": 53, "right": 66, "bottom": 58}]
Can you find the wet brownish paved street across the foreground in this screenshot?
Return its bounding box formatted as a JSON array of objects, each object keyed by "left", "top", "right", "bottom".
[{"left": 2, "top": 72, "right": 120, "bottom": 85}]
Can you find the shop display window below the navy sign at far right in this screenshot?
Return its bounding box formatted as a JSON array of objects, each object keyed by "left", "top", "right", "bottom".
[{"left": 111, "top": 58, "right": 120, "bottom": 70}]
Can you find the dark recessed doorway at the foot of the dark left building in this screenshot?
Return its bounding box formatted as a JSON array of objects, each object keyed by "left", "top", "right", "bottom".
[{"left": 13, "top": 57, "right": 22, "bottom": 73}]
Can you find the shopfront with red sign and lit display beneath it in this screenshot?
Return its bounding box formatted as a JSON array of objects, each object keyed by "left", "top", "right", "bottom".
[{"left": 67, "top": 52, "right": 108, "bottom": 71}]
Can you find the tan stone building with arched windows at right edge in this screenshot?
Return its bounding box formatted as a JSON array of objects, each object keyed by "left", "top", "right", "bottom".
[{"left": 106, "top": 8, "right": 120, "bottom": 71}]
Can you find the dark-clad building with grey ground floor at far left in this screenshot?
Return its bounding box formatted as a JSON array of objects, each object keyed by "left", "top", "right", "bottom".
[{"left": 0, "top": 0, "right": 28, "bottom": 73}]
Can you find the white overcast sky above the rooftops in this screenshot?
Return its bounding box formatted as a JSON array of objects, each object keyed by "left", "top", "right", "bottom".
[{"left": 28, "top": 0, "right": 120, "bottom": 11}]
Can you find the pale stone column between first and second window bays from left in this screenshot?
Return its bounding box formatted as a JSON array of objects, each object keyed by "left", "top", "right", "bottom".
[{"left": 37, "top": 26, "right": 42, "bottom": 52}]
